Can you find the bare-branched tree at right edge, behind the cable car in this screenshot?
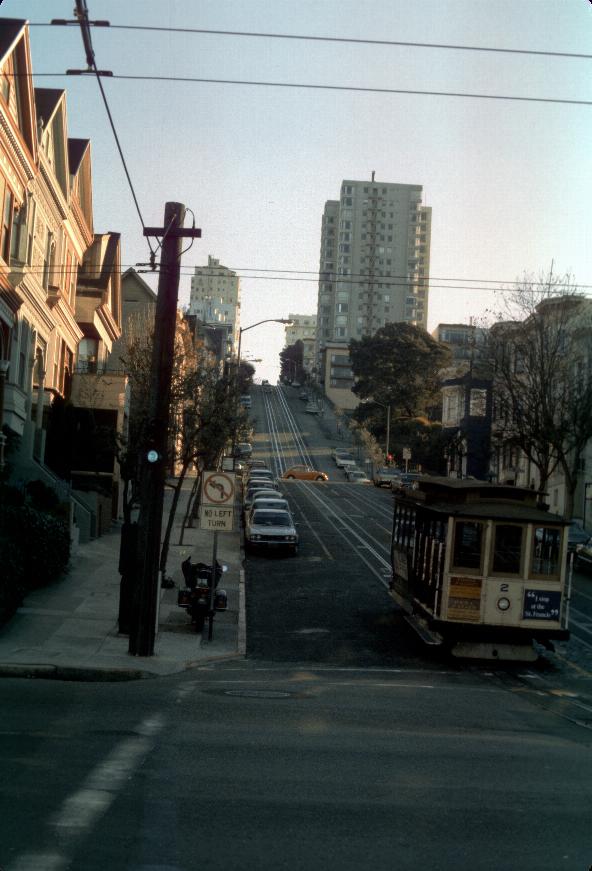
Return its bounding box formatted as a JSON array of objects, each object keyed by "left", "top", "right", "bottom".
[{"left": 489, "top": 270, "right": 592, "bottom": 517}]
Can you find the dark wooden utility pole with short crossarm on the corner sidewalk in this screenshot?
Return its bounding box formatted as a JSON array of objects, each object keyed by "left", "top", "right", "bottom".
[{"left": 129, "top": 203, "right": 201, "bottom": 656}]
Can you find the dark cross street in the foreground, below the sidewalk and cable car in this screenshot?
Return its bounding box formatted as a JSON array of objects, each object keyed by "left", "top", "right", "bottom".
[{"left": 0, "top": 662, "right": 592, "bottom": 871}]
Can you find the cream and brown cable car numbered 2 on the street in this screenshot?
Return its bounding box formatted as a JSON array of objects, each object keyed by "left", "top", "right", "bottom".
[{"left": 390, "top": 477, "right": 571, "bottom": 661}]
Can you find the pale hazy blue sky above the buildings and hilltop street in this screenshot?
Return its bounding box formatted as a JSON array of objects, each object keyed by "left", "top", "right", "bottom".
[{"left": 6, "top": 0, "right": 592, "bottom": 380}]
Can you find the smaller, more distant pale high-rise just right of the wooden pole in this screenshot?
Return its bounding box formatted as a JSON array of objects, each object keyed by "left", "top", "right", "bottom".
[{"left": 188, "top": 256, "right": 240, "bottom": 352}]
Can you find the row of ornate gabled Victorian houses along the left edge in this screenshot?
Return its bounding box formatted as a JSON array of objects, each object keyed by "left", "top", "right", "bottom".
[{"left": 0, "top": 19, "right": 125, "bottom": 534}]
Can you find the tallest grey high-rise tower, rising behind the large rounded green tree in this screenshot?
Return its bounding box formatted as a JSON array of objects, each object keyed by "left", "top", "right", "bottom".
[{"left": 317, "top": 173, "right": 432, "bottom": 370}]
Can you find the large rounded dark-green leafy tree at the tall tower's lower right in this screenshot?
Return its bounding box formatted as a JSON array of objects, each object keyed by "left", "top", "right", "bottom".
[{"left": 349, "top": 323, "right": 450, "bottom": 418}]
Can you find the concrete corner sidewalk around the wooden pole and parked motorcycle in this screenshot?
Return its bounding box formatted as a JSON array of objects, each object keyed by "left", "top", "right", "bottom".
[{"left": 0, "top": 479, "right": 246, "bottom": 681}]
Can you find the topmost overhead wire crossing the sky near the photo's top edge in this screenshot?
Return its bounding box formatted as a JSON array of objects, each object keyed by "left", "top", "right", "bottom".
[{"left": 30, "top": 19, "right": 592, "bottom": 60}]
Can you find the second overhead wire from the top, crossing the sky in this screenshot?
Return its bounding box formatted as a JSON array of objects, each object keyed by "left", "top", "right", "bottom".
[{"left": 25, "top": 70, "right": 592, "bottom": 106}]
